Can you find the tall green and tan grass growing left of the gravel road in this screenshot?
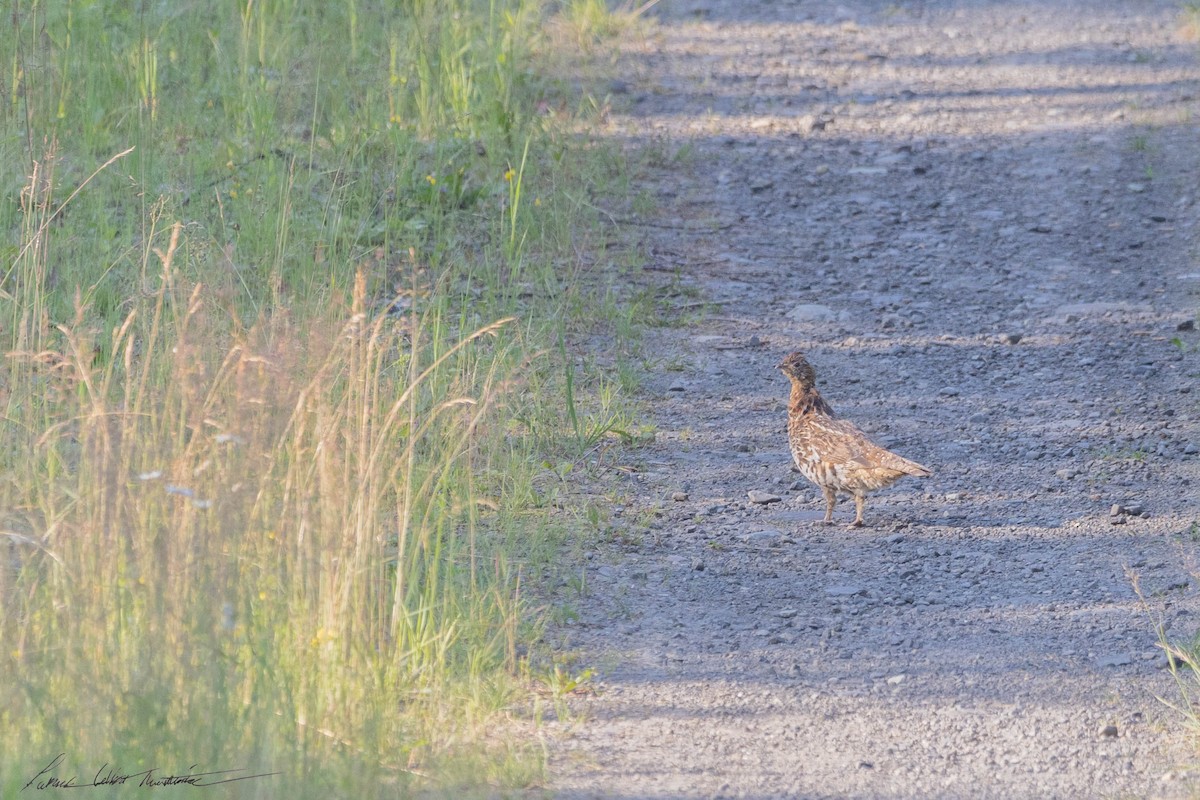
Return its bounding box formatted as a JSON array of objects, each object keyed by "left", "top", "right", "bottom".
[{"left": 0, "top": 0, "right": 629, "bottom": 798}]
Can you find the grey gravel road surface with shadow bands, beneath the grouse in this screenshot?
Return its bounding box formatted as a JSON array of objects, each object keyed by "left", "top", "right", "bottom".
[{"left": 550, "top": 0, "right": 1200, "bottom": 798}]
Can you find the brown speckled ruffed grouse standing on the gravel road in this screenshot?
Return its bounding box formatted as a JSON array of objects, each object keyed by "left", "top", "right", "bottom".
[{"left": 779, "top": 353, "right": 932, "bottom": 527}]
